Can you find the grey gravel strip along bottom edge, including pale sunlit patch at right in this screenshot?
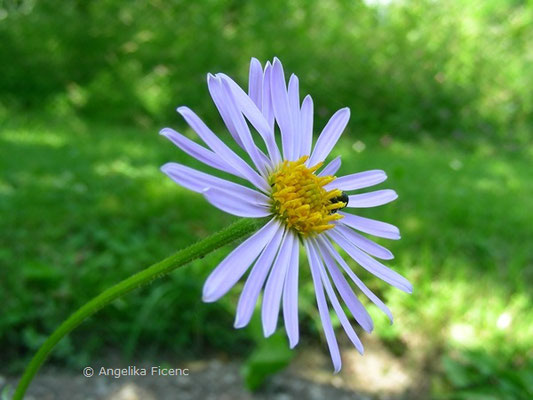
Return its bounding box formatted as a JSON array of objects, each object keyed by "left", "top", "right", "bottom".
[{"left": 0, "top": 340, "right": 428, "bottom": 400}]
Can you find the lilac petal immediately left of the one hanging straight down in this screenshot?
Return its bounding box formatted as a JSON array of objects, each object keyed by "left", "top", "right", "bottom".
[{"left": 261, "top": 230, "right": 295, "bottom": 337}]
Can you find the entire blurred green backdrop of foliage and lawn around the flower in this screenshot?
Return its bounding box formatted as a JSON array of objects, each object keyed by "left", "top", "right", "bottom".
[{"left": 0, "top": 0, "right": 533, "bottom": 399}]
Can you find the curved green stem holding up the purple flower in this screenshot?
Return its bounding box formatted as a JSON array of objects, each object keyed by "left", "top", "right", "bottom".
[{"left": 13, "top": 219, "right": 265, "bottom": 400}]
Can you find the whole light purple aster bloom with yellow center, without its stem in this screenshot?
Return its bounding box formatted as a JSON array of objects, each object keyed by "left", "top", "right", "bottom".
[{"left": 161, "top": 58, "right": 412, "bottom": 372}]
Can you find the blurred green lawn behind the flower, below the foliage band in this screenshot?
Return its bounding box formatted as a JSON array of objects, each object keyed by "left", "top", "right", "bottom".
[{"left": 0, "top": 113, "right": 533, "bottom": 398}]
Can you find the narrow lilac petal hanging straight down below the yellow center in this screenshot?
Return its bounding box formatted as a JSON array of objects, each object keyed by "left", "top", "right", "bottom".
[{"left": 283, "top": 233, "right": 300, "bottom": 349}]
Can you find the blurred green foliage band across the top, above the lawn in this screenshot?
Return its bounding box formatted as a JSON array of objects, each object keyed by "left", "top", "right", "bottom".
[{"left": 0, "top": 0, "right": 533, "bottom": 142}]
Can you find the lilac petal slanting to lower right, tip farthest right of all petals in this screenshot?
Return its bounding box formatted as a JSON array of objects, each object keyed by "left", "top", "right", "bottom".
[{"left": 327, "top": 229, "right": 413, "bottom": 293}]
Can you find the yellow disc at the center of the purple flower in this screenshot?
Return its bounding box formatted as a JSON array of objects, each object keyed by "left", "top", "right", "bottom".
[{"left": 270, "top": 156, "right": 346, "bottom": 236}]
